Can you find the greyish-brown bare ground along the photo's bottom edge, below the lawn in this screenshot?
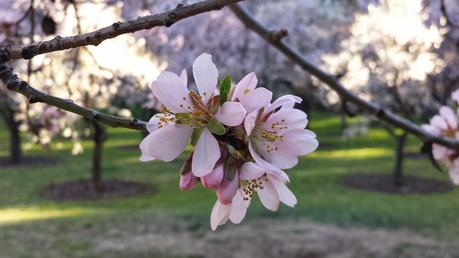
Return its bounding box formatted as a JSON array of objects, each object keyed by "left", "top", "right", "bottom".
[{"left": 93, "top": 217, "right": 459, "bottom": 258}]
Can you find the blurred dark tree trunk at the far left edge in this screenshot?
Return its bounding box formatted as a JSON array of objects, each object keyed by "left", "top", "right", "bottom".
[{"left": 0, "top": 108, "right": 22, "bottom": 164}]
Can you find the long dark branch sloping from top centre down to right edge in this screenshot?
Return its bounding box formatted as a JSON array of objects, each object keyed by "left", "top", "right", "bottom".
[{"left": 230, "top": 4, "right": 459, "bottom": 151}]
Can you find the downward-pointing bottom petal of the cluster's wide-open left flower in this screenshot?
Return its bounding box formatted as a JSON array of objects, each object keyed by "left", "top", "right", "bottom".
[{"left": 191, "top": 128, "right": 221, "bottom": 177}]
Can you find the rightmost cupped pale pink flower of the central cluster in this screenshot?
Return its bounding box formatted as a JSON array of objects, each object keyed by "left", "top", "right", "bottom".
[{"left": 241, "top": 87, "right": 319, "bottom": 169}]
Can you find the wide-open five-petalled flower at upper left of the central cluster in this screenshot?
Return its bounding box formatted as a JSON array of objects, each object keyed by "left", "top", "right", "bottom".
[{"left": 140, "top": 53, "right": 246, "bottom": 177}]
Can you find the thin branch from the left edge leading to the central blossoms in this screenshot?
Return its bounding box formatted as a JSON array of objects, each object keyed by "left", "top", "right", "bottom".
[{"left": 0, "top": 63, "right": 146, "bottom": 131}]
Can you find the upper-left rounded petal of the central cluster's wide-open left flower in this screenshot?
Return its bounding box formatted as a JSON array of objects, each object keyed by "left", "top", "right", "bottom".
[{"left": 151, "top": 71, "right": 193, "bottom": 113}]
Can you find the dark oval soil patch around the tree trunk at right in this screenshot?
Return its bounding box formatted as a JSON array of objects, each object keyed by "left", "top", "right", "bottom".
[{"left": 341, "top": 174, "right": 453, "bottom": 194}]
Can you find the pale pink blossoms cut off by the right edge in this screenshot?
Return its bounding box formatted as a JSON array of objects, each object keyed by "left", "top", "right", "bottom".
[{"left": 422, "top": 90, "right": 459, "bottom": 185}]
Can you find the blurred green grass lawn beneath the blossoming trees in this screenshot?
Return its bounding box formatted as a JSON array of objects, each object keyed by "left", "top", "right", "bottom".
[{"left": 0, "top": 113, "right": 459, "bottom": 258}]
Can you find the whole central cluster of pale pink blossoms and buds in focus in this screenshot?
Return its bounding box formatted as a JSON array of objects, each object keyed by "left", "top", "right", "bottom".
[{"left": 140, "top": 53, "right": 318, "bottom": 230}]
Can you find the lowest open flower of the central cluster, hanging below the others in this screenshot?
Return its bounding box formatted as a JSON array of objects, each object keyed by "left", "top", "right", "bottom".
[{"left": 210, "top": 162, "right": 297, "bottom": 230}]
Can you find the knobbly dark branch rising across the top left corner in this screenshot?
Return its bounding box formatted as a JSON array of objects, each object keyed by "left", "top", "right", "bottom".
[{"left": 3, "top": 0, "right": 243, "bottom": 59}]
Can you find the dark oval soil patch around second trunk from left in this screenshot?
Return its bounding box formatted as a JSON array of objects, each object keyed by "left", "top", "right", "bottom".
[{"left": 43, "top": 180, "right": 156, "bottom": 201}]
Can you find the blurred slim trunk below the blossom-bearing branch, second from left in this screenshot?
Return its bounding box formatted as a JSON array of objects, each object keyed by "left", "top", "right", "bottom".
[{"left": 91, "top": 122, "right": 107, "bottom": 191}]
